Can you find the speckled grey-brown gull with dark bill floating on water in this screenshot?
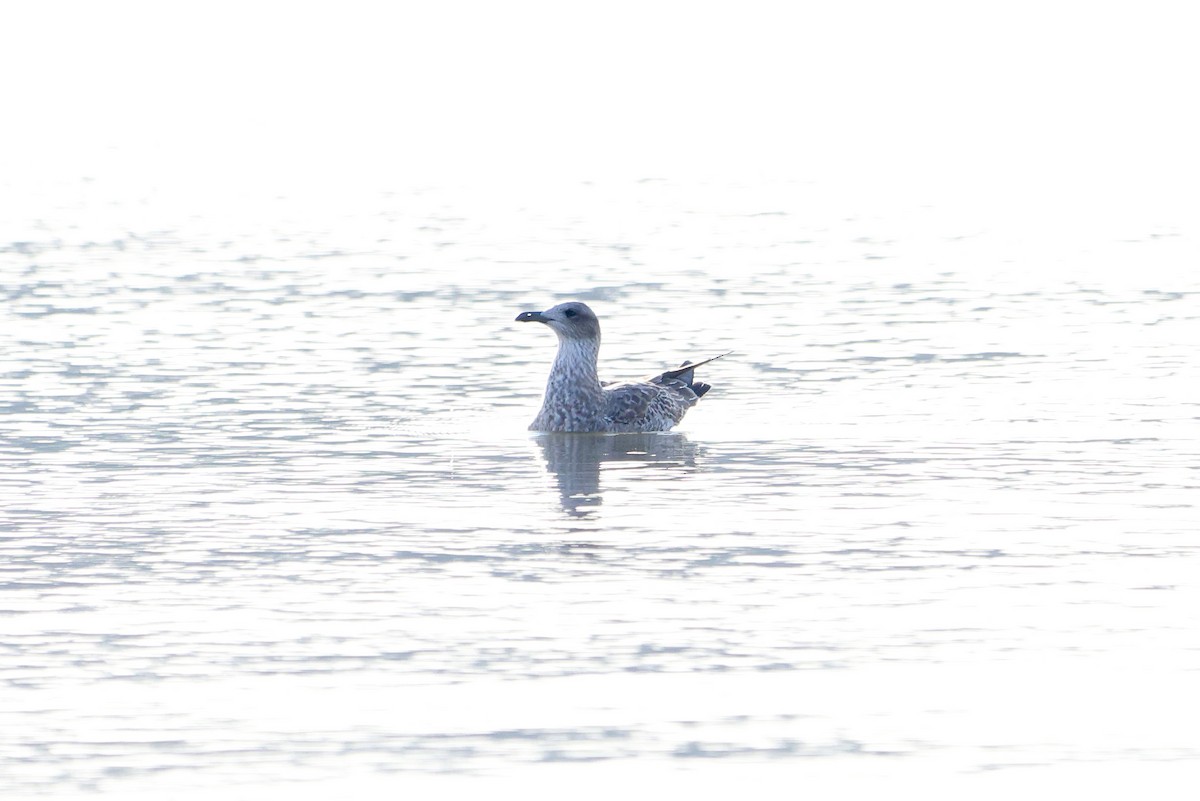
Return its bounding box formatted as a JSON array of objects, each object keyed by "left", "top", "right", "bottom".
[{"left": 516, "top": 301, "right": 725, "bottom": 433}]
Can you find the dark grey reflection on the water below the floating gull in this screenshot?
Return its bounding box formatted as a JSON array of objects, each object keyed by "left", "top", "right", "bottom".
[{"left": 536, "top": 433, "right": 700, "bottom": 517}]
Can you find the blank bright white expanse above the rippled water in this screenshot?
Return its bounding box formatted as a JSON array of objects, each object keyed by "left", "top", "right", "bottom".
[{"left": 0, "top": 0, "right": 1200, "bottom": 195}]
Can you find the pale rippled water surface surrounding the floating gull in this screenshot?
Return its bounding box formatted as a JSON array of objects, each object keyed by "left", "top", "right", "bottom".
[{"left": 0, "top": 181, "right": 1200, "bottom": 797}]
